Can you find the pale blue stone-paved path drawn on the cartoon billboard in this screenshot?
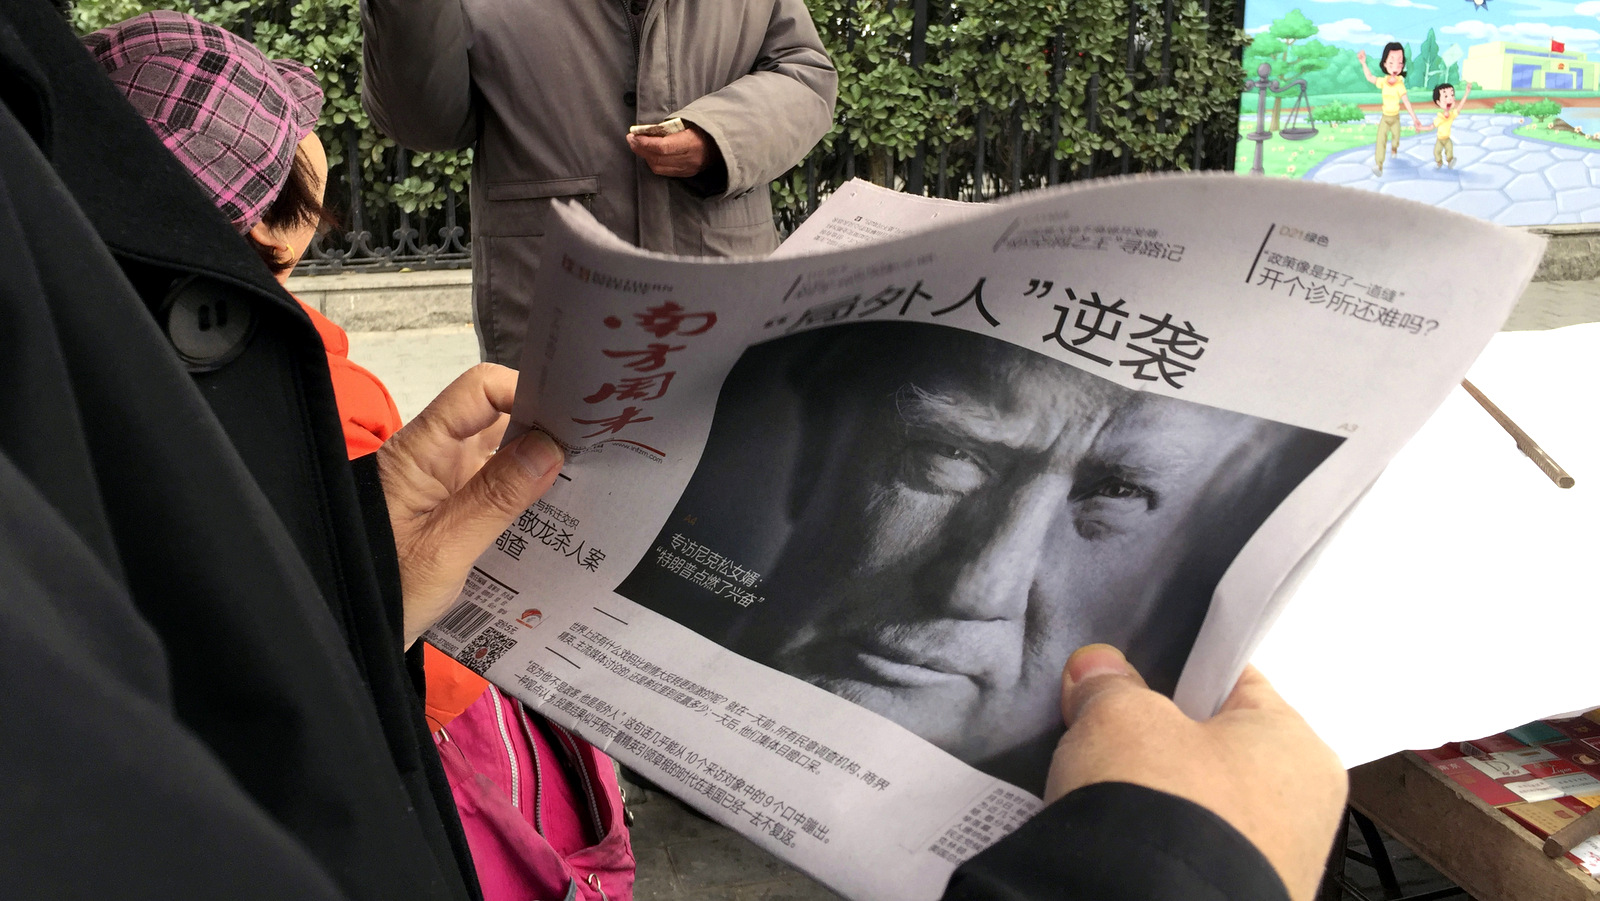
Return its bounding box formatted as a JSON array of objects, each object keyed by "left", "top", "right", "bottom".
[{"left": 1306, "top": 110, "right": 1600, "bottom": 226}]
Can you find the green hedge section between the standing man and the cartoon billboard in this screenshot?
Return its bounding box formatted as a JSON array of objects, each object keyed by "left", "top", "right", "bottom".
[{"left": 774, "top": 0, "right": 1246, "bottom": 208}]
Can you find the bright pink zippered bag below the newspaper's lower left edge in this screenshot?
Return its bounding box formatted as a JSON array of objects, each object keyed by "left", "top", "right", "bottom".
[{"left": 434, "top": 685, "right": 634, "bottom": 901}]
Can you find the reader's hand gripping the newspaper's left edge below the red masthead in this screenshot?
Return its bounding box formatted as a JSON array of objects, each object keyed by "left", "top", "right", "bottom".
[{"left": 378, "top": 363, "right": 563, "bottom": 647}]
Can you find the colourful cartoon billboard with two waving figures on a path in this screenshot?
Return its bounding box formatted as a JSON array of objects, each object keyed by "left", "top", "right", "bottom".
[{"left": 1237, "top": 0, "right": 1600, "bottom": 226}]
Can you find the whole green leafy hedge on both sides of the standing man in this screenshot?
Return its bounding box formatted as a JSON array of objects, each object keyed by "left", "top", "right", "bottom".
[{"left": 72, "top": 0, "right": 1246, "bottom": 240}]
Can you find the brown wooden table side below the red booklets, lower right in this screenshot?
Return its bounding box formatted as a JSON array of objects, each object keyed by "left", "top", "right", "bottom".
[{"left": 1350, "top": 751, "right": 1600, "bottom": 901}]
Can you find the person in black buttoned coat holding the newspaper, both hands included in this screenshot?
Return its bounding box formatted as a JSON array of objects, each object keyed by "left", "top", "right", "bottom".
[{"left": 0, "top": 0, "right": 1342, "bottom": 901}]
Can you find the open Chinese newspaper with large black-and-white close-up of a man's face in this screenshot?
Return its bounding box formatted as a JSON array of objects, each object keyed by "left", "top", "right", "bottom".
[{"left": 427, "top": 176, "right": 1542, "bottom": 901}]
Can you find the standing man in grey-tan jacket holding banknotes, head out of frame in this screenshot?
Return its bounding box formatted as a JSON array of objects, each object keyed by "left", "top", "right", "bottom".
[{"left": 362, "top": 0, "right": 838, "bottom": 366}]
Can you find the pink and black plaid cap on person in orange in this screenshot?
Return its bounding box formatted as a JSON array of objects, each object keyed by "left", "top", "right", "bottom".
[{"left": 83, "top": 10, "right": 322, "bottom": 232}]
